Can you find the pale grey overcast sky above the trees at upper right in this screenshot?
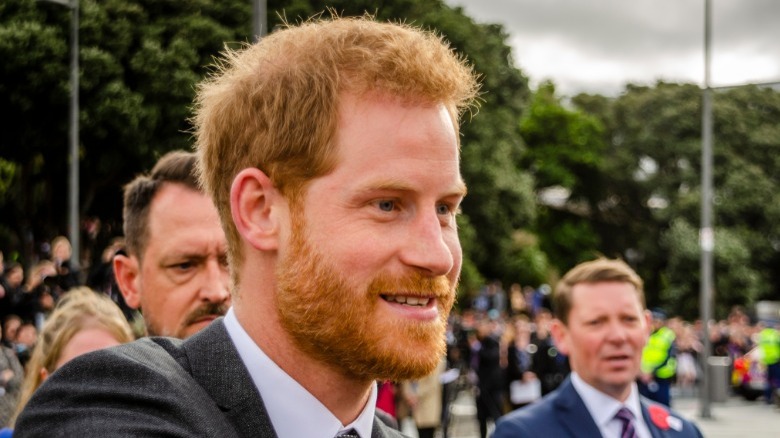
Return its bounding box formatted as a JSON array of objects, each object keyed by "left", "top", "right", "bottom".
[{"left": 446, "top": 0, "right": 780, "bottom": 95}]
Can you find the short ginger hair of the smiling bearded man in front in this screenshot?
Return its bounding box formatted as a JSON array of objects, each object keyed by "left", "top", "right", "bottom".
[{"left": 193, "top": 16, "right": 479, "bottom": 281}]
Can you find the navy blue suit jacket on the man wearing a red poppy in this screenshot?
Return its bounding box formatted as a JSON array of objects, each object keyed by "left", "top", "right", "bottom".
[{"left": 493, "top": 379, "right": 702, "bottom": 438}]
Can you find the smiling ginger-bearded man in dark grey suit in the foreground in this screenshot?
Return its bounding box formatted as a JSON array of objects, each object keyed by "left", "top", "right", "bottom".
[{"left": 17, "top": 17, "right": 478, "bottom": 438}]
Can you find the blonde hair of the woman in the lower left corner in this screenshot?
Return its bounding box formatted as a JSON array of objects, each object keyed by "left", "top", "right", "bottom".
[{"left": 12, "top": 287, "right": 134, "bottom": 421}]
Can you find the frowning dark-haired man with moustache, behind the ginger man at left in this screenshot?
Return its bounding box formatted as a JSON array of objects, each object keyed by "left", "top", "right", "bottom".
[{"left": 113, "top": 151, "right": 230, "bottom": 338}]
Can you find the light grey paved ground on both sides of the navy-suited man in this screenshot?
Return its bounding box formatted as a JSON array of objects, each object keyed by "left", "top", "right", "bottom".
[{"left": 402, "top": 391, "right": 780, "bottom": 438}]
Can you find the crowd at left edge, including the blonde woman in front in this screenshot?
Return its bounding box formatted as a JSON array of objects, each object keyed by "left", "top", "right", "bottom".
[{"left": 0, "top": 236, "right": 140, "bottom": 430}]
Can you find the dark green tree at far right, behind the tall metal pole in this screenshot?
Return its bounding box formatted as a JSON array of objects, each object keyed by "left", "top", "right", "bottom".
[{"left": 574, "top": 83, "right": 780, "bottom": 317}]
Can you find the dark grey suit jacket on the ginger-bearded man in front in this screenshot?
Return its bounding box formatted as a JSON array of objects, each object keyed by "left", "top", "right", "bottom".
[{"left": 14, "top": 319, "right": 403, "bottom": 438}]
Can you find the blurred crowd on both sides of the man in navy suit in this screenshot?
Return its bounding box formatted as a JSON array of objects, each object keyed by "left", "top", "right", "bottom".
[{"left": 380, "top": 282, "right": 780, "bottom": 438}]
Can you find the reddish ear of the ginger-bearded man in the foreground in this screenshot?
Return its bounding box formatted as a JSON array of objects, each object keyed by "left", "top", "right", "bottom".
[{"left": 230, "top": 168, "right": 287, "bottom": 251}]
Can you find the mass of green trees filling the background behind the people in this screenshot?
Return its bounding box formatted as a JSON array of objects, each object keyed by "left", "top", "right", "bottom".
[{"left": 0, "top": 0, "right": 780, "bottom": 317}]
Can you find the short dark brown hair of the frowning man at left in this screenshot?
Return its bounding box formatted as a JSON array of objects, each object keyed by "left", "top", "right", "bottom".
[{"left": 122, "top": 151, "right": 202, "bottom": 259}]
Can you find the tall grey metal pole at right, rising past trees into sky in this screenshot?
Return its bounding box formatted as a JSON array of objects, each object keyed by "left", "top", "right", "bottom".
[{"left": 699, "top": 0, "right": 715, "bottom": 418}]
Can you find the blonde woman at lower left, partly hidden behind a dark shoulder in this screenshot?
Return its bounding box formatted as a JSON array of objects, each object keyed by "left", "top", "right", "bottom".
[{"left": 11, "top": 287, "right": 134, "bottom": 425}]
